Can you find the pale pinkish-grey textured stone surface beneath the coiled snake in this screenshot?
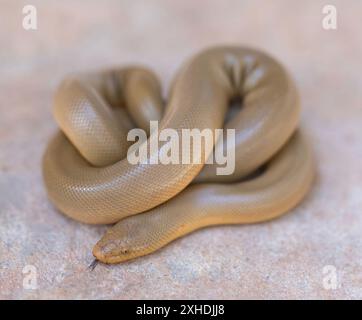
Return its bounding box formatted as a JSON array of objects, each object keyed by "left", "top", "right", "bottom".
[{"left": 0, "top": 0, "right": 362, "bottom": 299}]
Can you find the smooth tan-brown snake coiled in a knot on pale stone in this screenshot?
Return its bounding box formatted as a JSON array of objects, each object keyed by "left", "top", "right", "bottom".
[{"left": 42, "top": 46, "right": 315, "bottom": 264}]
